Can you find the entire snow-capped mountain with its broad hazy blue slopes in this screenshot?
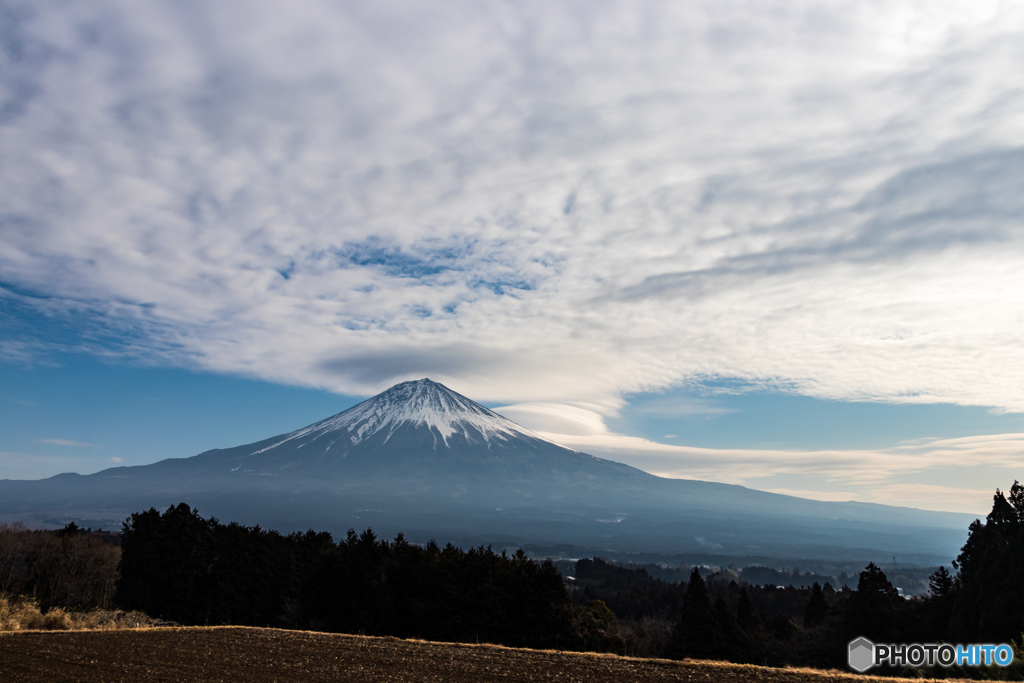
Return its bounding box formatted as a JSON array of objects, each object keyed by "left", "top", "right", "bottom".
[{"left": 0, "top": 379, "right": 974, "bottom": 566}]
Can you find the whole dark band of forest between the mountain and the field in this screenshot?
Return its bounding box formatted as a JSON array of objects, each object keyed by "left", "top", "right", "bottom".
[{"left": 0, "top": 482, "right": 1024, "bottom": 680}]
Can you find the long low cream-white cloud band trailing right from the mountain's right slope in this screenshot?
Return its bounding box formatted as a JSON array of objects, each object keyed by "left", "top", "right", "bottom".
[{"left": 495, "top": 403, "right": 1024, "bottom": 514}]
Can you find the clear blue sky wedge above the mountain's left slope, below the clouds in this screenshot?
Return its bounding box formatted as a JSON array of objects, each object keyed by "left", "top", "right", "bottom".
[{"left": 0, "top": 354, "right": 361, "bottom": 479}]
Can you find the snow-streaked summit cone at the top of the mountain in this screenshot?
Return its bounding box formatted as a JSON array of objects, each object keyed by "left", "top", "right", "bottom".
[{"left": 253, "top": 378, "right": 546, "bottom": 455}]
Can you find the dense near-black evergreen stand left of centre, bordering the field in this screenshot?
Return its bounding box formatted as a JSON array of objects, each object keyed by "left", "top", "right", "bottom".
[{"left": 118, "top": 503, "right": 598, "bottom": 648}]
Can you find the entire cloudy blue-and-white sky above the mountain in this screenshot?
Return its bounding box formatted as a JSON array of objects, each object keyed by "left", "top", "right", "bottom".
[{"left": 0, "top": 0, "right": 1024, "bottom": 513}]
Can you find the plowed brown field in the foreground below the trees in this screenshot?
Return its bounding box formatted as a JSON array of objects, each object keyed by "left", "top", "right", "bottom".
[{"left": 0, "top": 627, "right": 948, "bottom": 683}]
